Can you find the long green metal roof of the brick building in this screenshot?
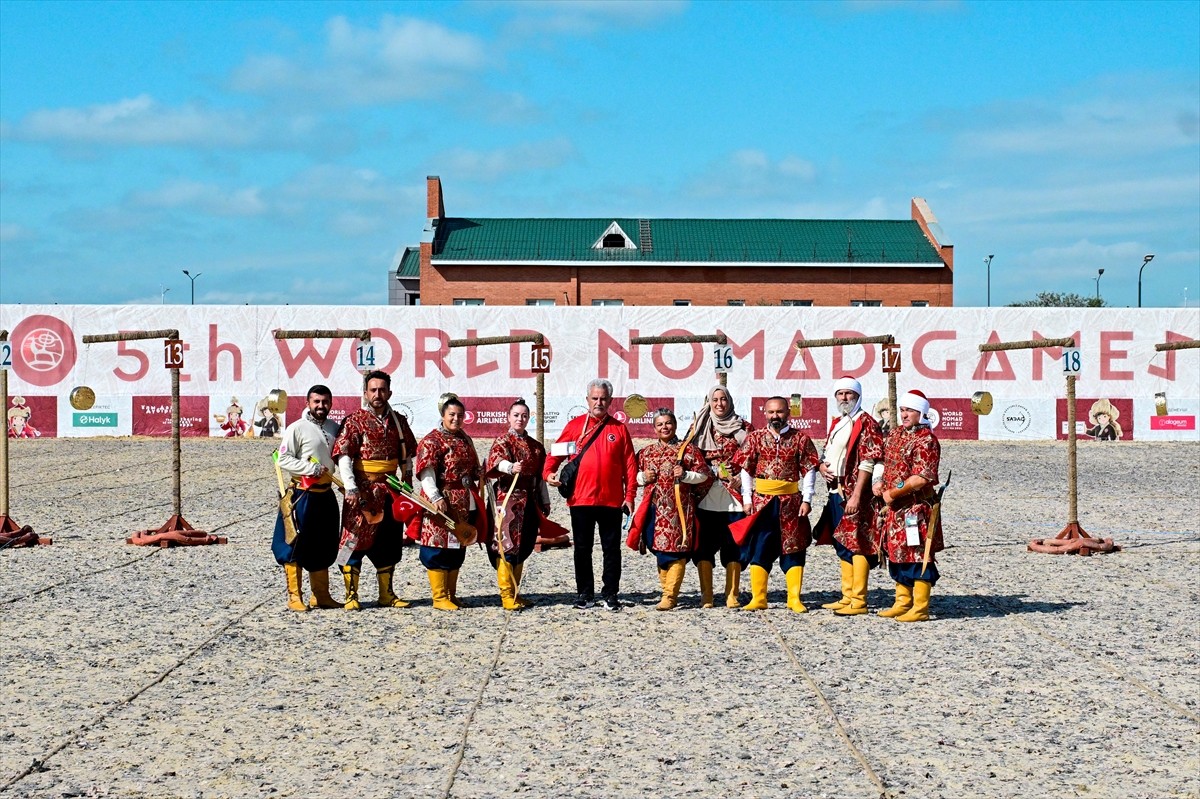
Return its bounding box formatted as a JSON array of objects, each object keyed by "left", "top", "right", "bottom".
[{"left": 433, "top": 217, "right": 942, "bottom": 265}]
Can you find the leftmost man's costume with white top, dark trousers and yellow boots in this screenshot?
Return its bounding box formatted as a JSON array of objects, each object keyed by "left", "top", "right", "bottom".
[{"left": 271, "top": 410, "right": 342, "bottom": 611}]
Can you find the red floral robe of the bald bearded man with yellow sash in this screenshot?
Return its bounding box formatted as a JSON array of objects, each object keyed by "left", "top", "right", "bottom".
[{"left": 733, "top": 427, "right": 821, "bottom": 554}]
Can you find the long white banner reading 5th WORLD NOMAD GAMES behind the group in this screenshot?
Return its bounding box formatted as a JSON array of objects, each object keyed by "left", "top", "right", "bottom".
[{"left": 0, "top": 305, "right": 1200, "bottom": 440}]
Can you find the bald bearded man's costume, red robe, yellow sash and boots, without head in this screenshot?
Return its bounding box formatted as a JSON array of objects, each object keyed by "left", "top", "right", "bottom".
[{"left": 731, "top": 426, "right": 820, "bottom": 613}]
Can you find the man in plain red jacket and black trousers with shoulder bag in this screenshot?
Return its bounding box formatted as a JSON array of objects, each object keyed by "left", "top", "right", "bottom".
[{"left": 542, "top": 379, "right": 637, "bottom": 611}]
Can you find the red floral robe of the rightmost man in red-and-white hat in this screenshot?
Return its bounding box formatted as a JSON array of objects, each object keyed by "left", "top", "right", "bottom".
[{"left": 877, "top": 426, "right": 942, "bottom": 563}]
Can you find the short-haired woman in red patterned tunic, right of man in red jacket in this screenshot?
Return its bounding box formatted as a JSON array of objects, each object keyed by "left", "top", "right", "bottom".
[{"left": 631, "top": 408, "right": 713, "bottom": 611}]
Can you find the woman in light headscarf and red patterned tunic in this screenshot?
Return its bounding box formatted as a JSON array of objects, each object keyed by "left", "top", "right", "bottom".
[{"left": 692, "top": 385, "right": 754, "bottom": 607}]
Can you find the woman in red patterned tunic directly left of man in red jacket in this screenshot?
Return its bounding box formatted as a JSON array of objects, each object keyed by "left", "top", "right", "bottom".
[{"left": 487, "top": 400, "right": 550, "bottom": 611}]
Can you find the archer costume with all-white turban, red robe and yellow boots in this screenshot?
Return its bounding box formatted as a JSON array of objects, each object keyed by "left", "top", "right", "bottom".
[{"left": 815, "top": 377, "right": 883, "bottom": 615}]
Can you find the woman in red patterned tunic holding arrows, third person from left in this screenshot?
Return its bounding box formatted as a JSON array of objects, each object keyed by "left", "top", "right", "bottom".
[{"left": 415, "top": 397, "right": 481, "bottom": 611}]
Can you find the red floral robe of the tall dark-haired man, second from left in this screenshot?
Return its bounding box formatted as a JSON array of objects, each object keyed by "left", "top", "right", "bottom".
[{"left": 332, "top": 408, "right": 416, "bottom": 552}]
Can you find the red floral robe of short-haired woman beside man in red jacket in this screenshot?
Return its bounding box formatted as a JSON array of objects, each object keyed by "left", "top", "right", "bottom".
[{"left": 637, "top": 441, "right": 713, "bottom": 552}]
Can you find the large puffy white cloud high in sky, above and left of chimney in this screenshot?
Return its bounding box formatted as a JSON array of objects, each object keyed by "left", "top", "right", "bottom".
[{"left": 230, "top": 16, "right": 488, "bottom": 106}]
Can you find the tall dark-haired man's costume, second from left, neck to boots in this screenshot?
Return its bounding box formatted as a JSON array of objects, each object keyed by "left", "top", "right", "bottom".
[{"left": 334, "top": 408, "right": 416, "bottom": 611}]
